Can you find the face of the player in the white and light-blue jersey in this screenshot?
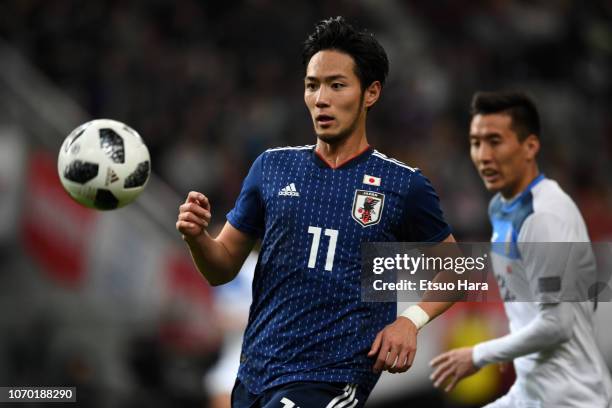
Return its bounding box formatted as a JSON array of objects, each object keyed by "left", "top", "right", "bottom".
[{"left": 470, "top": 113, "right": 540, "bottom": 198}]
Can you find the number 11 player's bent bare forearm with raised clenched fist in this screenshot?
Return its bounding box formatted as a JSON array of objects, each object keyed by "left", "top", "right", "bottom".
[{"left": 176, "top": 191, "right": 256, "bottom": 286}]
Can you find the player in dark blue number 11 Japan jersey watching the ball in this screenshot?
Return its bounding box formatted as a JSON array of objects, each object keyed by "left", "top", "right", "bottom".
[{"left": 176, "top": 17, "right": 454, "bottom": 408}]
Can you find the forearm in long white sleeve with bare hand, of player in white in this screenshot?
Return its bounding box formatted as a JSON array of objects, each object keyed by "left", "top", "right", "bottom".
[{"left": 430, "top": 303, "right": 574, "bottom": 392}]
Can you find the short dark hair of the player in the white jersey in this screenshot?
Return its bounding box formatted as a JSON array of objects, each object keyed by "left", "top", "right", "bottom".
[{"left": 470, "top": 91, "right": 540, "bottom": 141}]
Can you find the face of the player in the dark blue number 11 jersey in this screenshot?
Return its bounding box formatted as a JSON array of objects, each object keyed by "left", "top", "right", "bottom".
[{"left": 304, "top": 50, "right": 380, "bottom": 143}]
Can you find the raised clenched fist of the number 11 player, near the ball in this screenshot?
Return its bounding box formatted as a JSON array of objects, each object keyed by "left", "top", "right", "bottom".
[{"left": 176, "top": 191, "right": 211, "bottom": 241}]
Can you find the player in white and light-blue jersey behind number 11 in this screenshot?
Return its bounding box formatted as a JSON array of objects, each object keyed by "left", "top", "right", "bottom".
[{"left": 432, "top": 92, "right": 612, "bottom": 408}]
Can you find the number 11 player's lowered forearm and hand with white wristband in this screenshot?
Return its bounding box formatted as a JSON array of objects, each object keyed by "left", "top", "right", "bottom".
[{"left": 368, "top": 234, "right": 456, "bottom": 373}]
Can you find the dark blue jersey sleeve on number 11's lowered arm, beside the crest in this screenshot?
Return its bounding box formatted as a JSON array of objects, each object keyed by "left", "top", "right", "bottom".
[{"left": 402, "top": 171, "right": 451, "bottom": 242}]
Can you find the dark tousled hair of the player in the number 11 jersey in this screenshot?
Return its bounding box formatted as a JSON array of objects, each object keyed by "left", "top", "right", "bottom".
[{"left": 302, "top": 16, "right": 389, "bottom": 90}]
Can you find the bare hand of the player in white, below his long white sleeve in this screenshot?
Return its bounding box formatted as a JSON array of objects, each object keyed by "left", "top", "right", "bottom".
[{"left": 429, "top": 347, "right": 480, "bottom": 392}]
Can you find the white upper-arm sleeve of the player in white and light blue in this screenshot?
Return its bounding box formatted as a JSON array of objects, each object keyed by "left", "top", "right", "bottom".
[{"left": 518, "top": 213, "right": 595, "bottom": 303}]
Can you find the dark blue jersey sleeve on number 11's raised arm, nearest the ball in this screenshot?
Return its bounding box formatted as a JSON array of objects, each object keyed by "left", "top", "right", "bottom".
[{"left": 227, "top": 154, "right": 264, "bottom": 238}]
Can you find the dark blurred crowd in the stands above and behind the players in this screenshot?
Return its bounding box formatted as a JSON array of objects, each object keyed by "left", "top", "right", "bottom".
[{"left": 0, "top": 0, "right": 612, "bottom": 240}]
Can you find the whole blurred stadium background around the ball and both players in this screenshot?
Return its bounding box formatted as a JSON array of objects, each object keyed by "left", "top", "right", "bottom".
[{"left": 0, "top": 0, "right": 612, "bottom": 407}]
